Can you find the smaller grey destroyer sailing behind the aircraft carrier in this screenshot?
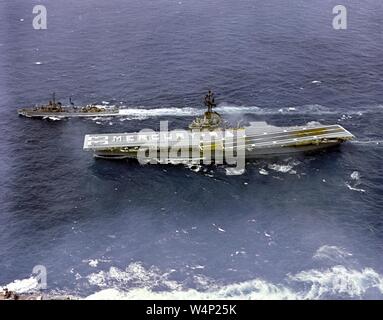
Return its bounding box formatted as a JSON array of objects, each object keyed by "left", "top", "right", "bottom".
[{"left": 17, "top": 93, "right": 119, "bottom": 120}]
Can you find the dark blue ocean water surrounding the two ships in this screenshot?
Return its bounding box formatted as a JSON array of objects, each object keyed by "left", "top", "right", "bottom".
[{"left": 0, "top": 0, "right": 383, "bottom": 299}]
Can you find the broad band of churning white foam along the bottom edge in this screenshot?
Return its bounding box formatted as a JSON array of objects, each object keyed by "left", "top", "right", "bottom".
[{"left": 86, "top": 258, "right": 383, "bottom": 300}]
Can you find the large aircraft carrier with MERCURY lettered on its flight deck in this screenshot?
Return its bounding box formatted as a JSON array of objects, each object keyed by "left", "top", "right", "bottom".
[{"left": 83, "top": 91, "right": 354, "bottom": 163}]
